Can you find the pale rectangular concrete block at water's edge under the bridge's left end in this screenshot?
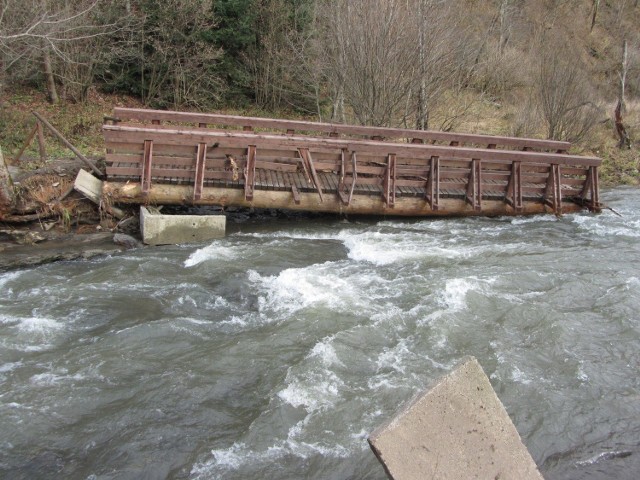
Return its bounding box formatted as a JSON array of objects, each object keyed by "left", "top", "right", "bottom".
[{"left": 140, "top": 207, "right": 227, "bottom": 245}]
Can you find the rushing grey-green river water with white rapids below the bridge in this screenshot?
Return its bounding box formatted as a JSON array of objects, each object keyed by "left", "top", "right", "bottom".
[{"left": 0, "top": 188, "right": 640, "bottom": 479}]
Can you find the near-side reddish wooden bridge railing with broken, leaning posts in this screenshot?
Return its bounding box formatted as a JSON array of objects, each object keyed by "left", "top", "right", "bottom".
[{"left": 104, "top": 118, "right": 601, "bottom": 213}]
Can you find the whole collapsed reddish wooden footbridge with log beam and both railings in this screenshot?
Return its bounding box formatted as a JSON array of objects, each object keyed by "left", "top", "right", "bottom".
[{"left": 103, "top": 108, "right": 601, "bottom": 216}]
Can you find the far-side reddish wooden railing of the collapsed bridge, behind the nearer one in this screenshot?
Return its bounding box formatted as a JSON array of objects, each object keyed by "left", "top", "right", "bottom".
[{"left": 107, "top": 108, "right": 571, "bottom": 153}]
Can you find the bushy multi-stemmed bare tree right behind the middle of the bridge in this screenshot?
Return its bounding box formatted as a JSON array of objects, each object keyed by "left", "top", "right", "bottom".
[{"left": 322, "top": 0, "right": 416, "bottom": 125}]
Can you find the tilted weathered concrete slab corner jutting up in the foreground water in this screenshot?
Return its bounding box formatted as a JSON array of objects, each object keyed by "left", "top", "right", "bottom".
[{"left": 369, "top": 357, "right": 542, "bottom": 480}]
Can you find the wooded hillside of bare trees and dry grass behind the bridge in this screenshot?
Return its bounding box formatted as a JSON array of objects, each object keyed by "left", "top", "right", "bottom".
[{"left": 0, "top": 0, "right": 640, "bottom": 183}]
